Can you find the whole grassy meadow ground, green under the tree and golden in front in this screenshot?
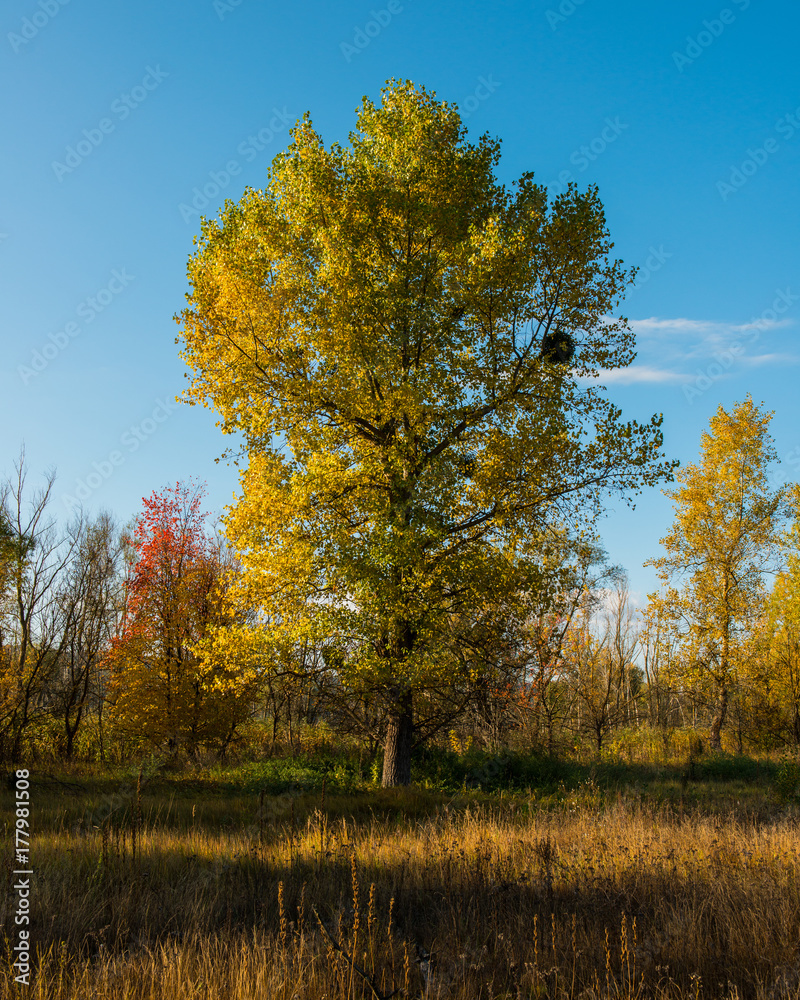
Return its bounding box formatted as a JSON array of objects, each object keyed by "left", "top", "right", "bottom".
[{"left": 0, "top": 752, "right": 800, "bottom": 1000}]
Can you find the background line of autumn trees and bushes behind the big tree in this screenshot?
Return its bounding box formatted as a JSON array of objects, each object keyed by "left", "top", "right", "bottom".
[{"left": 0, "top": 397, "right": 800, "bottom": 761}]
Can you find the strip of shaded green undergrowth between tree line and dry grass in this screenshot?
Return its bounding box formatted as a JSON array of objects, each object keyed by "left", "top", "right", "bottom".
[{"left": 7, "top": 748, "right": 800, "bottom": 830}]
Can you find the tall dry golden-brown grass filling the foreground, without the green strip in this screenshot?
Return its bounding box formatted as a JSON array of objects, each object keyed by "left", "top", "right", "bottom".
[{"left": 0, "top": 791, "right": 800, "bottom": 1000}]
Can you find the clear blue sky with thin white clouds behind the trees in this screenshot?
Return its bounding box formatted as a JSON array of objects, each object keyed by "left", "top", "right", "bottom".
[{"left": 0, "top": 0, "right": 800, "bottom": 595}]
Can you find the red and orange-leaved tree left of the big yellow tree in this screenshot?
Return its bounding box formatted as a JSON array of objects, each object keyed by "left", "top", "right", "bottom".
[{"left": 108, "top": 483, "right": 255, "bottom": 756}]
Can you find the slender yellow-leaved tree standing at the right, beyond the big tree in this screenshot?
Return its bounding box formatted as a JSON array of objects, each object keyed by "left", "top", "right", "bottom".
[{"left": 645, "top": 395, "right": 788, "bottom": 749}]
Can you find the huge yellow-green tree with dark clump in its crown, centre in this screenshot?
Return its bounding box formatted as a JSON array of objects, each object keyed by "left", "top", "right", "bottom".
[{"left": 179, "top": 81, "right": 672, "bottom": 785}]
